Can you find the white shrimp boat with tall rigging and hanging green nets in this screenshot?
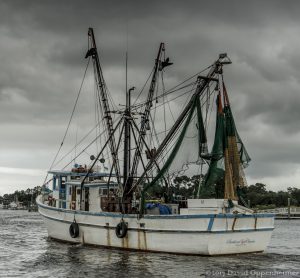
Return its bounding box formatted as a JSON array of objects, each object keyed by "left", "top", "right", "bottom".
[{"left": 37, "top": 28, "right": 274, "bottom": 255}]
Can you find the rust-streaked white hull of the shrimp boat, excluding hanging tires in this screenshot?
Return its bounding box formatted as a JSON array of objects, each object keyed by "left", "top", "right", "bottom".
[{"left": 37, "top": 197, "right": 274, "bottom": 255}]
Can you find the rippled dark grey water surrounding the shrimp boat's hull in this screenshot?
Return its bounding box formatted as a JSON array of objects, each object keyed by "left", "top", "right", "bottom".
[{"left": 0, "top": 210, "right": 300, "bottom": 278}]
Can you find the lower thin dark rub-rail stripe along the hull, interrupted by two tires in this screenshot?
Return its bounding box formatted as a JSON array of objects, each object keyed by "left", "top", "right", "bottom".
[{"left": 41, "top": 213, "right": 274, "bottom": 234}]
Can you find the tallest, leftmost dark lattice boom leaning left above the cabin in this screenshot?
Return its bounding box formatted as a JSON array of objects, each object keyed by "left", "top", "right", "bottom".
[{"left": 85, "top": 28, "right": 121, "bottom": 184}]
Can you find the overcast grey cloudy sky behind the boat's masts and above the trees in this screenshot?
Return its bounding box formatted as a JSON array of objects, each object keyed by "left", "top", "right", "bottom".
[{"left": 0, "top": 0, "right": 300, "bottom": 195}]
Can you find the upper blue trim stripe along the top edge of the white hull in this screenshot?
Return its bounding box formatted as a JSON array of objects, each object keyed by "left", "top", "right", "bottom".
[{"left": 37, "top": 202, "right": 275, "bottom": 219}]
